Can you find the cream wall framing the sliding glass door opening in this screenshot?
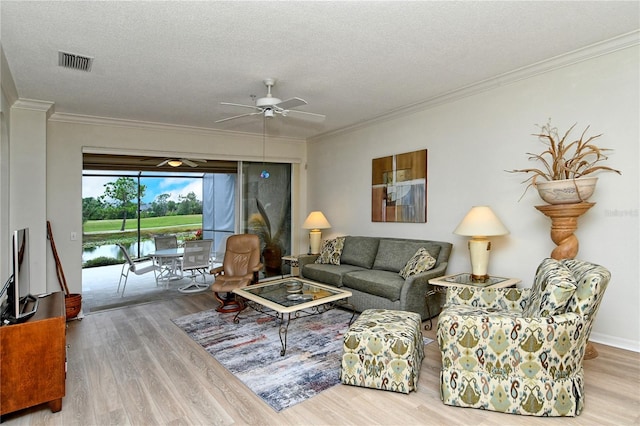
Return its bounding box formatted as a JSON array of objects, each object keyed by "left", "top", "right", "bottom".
[{"left": 45, "top": 118, "right": 306, "bottom": 293}]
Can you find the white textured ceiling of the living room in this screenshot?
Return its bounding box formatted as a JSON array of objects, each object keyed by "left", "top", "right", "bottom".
[{"left": 0, "top": 0, "right": 640, "bottom": 138}]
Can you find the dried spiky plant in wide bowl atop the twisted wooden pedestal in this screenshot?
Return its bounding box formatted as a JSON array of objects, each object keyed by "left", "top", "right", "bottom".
[{"left": 508, "top": 120, "right": 622, "bottom": 204}]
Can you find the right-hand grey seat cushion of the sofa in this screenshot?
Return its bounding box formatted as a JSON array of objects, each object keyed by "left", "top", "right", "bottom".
[{"left": 342, "top": 269, "right": 404, "bottom": 302}]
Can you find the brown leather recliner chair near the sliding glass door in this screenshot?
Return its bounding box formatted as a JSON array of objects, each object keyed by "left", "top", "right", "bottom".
[{"left": 211, "top": 234, "right": 263, "bottom": 312}]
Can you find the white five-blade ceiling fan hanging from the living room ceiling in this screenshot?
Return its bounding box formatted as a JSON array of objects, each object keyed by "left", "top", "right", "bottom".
[{"left": 216, "top": 78, "right": 325, "bottom": 123}]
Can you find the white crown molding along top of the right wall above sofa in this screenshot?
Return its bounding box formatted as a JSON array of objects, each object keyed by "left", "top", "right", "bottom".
[{"left": 307, "top": 30, "right": 640, "bottom": 142}]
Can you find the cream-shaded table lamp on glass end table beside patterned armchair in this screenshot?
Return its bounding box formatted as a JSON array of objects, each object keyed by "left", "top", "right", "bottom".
[{"left": 453, "top": 206, "right": 509, "bottom": 282}]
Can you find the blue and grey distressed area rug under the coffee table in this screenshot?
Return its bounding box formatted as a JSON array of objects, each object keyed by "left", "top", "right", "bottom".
[{"left": 172, "top": 309, "right": 432, "bottom": 411}]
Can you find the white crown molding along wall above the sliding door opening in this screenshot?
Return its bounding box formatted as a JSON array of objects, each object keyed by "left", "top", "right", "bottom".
[{"left": 49, "top": 112, "right": 305, "bottom": 142}]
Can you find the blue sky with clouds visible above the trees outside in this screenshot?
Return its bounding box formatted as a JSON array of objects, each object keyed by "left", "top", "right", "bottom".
[{"left": 82, "top": 176, "right": 202, "bottom": 203}]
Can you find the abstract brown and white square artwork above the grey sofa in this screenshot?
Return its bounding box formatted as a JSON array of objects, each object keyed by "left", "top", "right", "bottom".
[{"left": 371, "top": 149, "right": 427, "bottom": 223}]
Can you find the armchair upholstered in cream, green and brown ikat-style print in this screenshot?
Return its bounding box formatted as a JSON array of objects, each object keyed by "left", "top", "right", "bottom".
[{"left": 437, "top": 259, "right": 611, "bottom": 416}]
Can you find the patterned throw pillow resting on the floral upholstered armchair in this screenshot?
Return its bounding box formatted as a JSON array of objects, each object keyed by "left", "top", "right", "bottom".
[{"left": 523, "top": 258, "right": 577, "bottom": 318}]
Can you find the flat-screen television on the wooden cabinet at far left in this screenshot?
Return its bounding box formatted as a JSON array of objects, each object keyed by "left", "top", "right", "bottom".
[{"left": 2, "top": 228, "right": 38, "bottom": 323}]
